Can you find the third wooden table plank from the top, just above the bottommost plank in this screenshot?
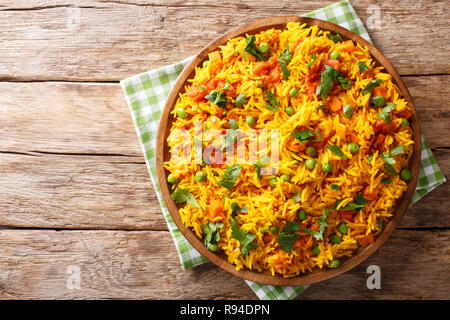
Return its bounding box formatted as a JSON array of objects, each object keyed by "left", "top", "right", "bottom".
[{"left": 0, "top": 150, "right": 450, "bottom": 230}]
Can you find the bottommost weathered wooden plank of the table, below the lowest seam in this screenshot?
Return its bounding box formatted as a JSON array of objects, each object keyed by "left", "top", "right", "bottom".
[{"left": 0, "top": 230, "right": 450, "bottom": 299}]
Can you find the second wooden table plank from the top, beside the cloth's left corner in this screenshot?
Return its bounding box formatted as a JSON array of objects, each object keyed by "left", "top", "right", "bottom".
[{"left": 0, "top": 76, "right": 450, "bottom": 157}]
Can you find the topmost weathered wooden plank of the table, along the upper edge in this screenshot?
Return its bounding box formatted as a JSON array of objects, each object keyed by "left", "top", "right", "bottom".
[{"left": 0, "top": 0, "right": 450, "bottom": 81}]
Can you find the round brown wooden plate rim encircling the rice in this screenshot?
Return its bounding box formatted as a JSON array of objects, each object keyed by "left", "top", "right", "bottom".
[{"left": 156, "top": 16, "right": 421, "bottom": 286}]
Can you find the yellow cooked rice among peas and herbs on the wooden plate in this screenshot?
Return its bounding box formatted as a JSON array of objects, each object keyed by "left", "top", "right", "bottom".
[{"left": 164, "top": 23, "right": 414, "bottom": 277}]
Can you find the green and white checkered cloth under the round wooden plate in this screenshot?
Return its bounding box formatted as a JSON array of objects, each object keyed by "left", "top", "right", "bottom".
[{"left": 121, "top": 0, "right": 445, "bottom": 300}]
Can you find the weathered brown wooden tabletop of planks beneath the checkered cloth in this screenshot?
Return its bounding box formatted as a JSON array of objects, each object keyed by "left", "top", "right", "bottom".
[{"left": 0, "top": 0, "right": 450, "bottom": 299}]
